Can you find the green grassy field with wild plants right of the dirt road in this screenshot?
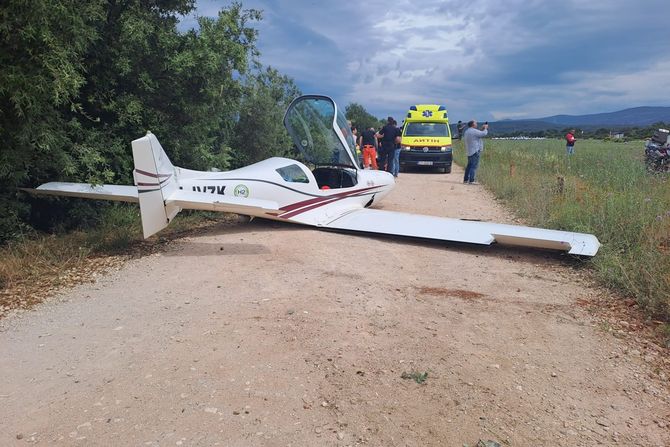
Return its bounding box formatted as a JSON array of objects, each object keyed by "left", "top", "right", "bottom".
[{"left": 455, "top": 140, "right": 670, "bottom": 321}]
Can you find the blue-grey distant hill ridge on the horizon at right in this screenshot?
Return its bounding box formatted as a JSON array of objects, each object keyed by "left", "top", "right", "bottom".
[{"left": 490, "top": 107, "right": 670, "bottom": 133}]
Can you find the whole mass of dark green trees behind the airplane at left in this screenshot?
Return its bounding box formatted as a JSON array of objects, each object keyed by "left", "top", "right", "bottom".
[{"left": 0, "top": 0, "right": 304, "bottom": 241}]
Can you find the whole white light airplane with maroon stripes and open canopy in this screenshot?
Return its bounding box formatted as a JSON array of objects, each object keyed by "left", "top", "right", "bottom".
[{"left": 29, "top": 95, "right": 600, "bottom": 256}]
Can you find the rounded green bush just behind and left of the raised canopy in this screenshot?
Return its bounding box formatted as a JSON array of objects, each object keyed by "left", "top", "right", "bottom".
[{"left": 233, "top": 67, "right": 301, "bottom": 166}]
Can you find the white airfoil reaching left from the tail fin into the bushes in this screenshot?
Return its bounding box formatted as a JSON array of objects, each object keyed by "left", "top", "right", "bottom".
[{"left": 23, "top": 182, "right": 139, "bottom": 203}]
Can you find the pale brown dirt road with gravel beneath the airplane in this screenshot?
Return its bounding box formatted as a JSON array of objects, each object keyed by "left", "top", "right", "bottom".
[{"left": 0, "top": 168, "right": 670, "bottom": 446}]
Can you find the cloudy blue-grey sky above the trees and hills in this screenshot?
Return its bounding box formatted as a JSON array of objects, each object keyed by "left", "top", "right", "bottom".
[{"left": 180, "top": 0, "right": 670, "bottom": 122}]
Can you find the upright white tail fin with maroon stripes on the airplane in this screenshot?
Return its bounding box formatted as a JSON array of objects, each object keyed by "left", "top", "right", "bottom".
[{"left": 132, "top": 132, "right": 181, "bottom": 238}]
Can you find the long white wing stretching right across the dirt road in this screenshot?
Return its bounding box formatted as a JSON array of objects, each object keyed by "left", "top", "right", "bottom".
[{"left": 321, "top": 208, "right": 600, "bottom": 256}]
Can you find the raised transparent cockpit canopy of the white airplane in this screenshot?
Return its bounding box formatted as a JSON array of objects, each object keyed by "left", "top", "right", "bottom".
[{"left": 284, "top": 96, "right": 358, "bottom": 168}]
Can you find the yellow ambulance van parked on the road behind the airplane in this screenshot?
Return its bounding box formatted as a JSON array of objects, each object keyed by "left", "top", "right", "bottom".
[{"left": 400, "top": 104, "right": 453, "bottom": 173}]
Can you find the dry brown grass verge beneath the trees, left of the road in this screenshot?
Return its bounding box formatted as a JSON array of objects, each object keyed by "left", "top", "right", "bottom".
[{"left": 0, "top": 206, "right": 237, "bottom": 317}]
